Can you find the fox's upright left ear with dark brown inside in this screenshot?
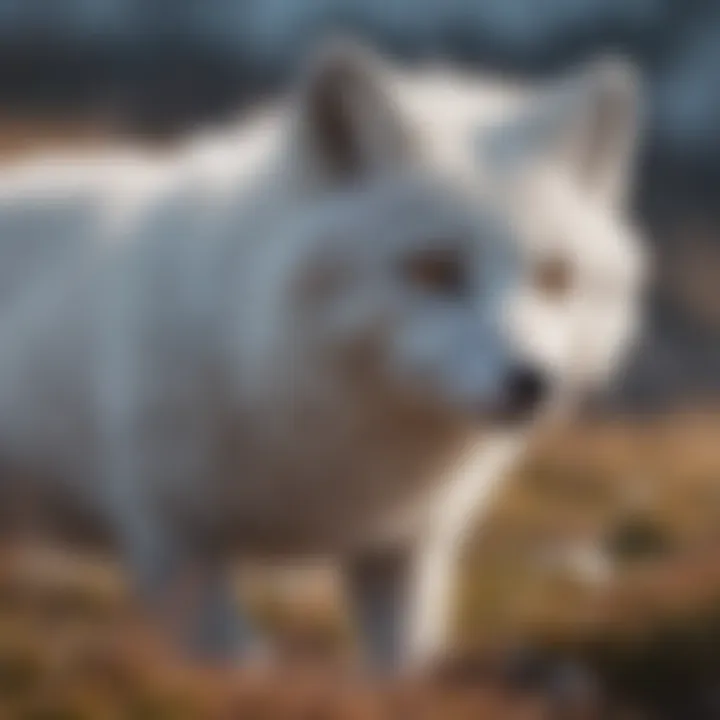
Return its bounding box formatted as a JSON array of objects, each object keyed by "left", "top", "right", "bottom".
[{"left": 298, "top": 39, "right": 408, "bottom": 183}]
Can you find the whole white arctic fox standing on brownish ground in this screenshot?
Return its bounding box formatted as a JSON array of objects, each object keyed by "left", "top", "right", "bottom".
[{"left": 0, "top": 42, "right": 644, "bottom": 667}]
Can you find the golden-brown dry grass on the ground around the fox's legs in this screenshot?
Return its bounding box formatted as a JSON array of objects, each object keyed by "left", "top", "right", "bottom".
[{"left": 0, "top": 416, "right": 708, "bottom": 720}]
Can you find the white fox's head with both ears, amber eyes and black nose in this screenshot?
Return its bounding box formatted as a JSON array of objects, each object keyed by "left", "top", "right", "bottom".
[{"left": 274, "top": 44, "right": 643, "bottom": 424}]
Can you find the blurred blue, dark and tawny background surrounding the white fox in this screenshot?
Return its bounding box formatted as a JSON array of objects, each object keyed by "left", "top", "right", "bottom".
[{"left": 0, "top": 0, "right": 720, "bottom": 720}]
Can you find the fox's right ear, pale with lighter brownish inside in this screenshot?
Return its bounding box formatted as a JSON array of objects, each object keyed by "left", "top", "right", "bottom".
[{"left": 486, "top": 57, "right": 641, "bottom": 210}]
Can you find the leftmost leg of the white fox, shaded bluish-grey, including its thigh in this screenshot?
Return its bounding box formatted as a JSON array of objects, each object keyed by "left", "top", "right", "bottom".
[{"left": 98, "top": 420, "right": 258, "bottom": 663}]
